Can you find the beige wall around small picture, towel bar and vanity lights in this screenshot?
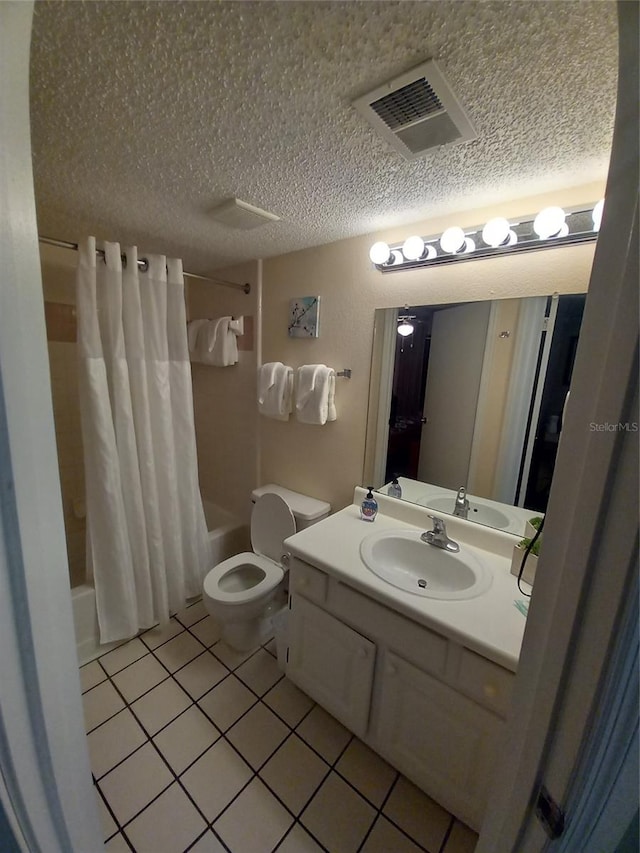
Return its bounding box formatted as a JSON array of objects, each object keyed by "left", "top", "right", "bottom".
[{"left": 259, "top": 184, "right": 603, "bottom": 509}]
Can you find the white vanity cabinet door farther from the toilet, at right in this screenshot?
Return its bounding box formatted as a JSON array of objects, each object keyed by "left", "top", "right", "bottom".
[{"left": 375, "top": 653, "right": 503, "bottom": 829}]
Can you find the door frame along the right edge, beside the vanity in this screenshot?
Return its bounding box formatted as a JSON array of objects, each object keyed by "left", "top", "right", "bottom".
[{"left": 476, "top": 2, "right": 639, "bottom": 853}]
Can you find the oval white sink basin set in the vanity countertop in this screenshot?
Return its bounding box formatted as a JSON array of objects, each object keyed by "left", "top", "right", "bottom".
[{"left": 360, "top": 529, "right": 492, "bottom": 599}]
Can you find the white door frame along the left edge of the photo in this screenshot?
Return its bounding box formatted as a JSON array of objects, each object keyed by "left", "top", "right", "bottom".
[{"left": 0, "top": 2, "right": 102, "bottom": 853}]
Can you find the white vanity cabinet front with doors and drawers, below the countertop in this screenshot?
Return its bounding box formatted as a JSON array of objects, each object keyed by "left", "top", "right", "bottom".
[{"left": 287, "top": 558, "right": 514, "bottom": 829}]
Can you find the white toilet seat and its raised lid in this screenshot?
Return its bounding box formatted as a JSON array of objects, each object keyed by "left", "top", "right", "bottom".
[{"left": 203, "top": 494, "right": 296, "bottom": 605}]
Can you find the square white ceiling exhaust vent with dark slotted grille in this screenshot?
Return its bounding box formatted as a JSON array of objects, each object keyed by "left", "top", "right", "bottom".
[{"left": 353, "top": 59, "right": 477, "bottom": 160}]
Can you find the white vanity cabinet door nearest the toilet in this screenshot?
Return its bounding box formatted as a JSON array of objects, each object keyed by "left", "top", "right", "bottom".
[{"left": 287, "top": 595, "right": 376, "bottom": 737}]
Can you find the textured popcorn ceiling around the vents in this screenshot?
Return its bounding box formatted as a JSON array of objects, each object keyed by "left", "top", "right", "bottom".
[{"left": 31, "top": 0, "right": 617, "bottom": 272}]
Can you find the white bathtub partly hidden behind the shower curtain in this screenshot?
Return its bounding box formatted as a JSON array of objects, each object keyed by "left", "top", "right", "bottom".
[{"left": 71, "top": 501, "right": 250, "bottom": 666}]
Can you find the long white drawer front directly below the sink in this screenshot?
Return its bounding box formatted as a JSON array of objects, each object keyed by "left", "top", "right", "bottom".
[{"left": 327, "top": 579, "right": 448, "bottom": 676}]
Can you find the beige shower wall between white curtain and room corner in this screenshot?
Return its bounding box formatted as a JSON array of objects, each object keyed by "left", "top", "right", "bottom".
[{"left": 187, "top": 261, "right": 260, "bottom": 522}]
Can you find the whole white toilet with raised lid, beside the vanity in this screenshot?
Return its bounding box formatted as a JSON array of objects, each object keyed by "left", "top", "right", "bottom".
[{"left": 202, "top": 483, "right": 331, "bottom": 651}]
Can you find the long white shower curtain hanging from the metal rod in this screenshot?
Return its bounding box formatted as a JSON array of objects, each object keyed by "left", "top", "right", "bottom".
[{"left": 77, "top": 237, "right": 208, "bottom": 643}]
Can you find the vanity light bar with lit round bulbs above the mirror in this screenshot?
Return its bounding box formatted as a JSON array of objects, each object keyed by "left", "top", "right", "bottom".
[{"left": 369, "top": 199, "right": 604, "bottom": 272}]
